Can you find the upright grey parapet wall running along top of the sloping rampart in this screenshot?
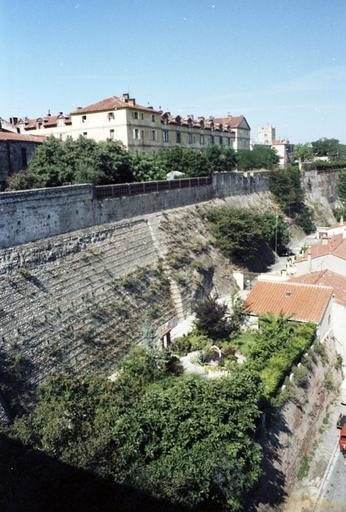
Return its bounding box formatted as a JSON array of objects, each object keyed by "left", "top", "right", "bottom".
[{"left": 0, "top": 172, "right": 269, "bottom": 248}]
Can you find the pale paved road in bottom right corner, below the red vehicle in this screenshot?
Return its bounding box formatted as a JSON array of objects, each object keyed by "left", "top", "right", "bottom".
[{"left": 316, "top": 449, "right": 346, "bottom": 512}]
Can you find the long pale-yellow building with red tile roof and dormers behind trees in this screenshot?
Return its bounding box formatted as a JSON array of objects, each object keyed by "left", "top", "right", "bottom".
[{"left": 8, "top": 93, "right": 250, "bottom": 151}]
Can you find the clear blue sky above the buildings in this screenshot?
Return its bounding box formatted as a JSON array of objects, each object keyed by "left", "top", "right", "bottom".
[{"left": 0, "top": 0, "right": 346, "bottom": 143}]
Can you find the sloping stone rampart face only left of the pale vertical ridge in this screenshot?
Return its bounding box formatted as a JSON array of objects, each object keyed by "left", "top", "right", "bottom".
[{"left": 0, "top": 215, "right": 175, "bottom": 400}]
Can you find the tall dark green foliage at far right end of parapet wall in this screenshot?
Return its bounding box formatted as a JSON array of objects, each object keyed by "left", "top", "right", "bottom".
[{"left": 270, "top": 166, "right": 315, "bottom": 234}]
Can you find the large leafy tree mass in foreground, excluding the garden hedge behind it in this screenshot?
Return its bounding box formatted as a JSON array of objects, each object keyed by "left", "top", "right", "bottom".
[{"left": 6, "top": 349, "right": 262, "bottom": 511}]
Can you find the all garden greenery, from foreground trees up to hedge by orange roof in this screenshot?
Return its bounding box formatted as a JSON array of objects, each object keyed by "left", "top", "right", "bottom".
[{"left": 3, "top": 284, "right": 315, "bottom": 512}]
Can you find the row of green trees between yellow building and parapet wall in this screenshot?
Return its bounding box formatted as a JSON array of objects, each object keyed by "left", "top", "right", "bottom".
[{"left": 9, "top": 137, "right": 237, "bottom": 190}]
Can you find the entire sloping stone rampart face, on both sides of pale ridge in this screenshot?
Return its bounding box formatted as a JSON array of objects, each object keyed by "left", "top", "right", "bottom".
[{"left": 0, "top": 194, "right": 253, "bottom": 416}]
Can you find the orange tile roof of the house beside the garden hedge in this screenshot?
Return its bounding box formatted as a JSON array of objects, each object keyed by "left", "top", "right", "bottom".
[{"left": 246, "top": 281, "right": 333, "bottom": 324}]
